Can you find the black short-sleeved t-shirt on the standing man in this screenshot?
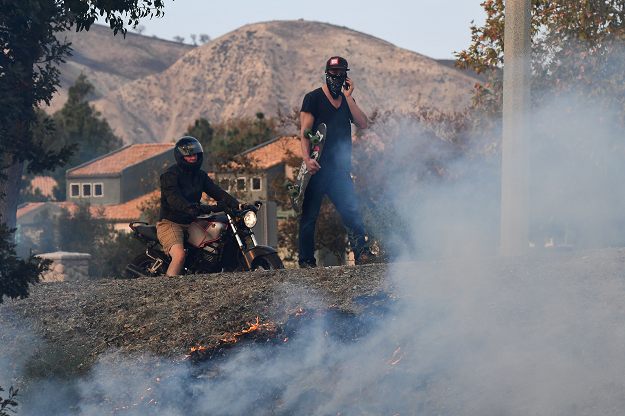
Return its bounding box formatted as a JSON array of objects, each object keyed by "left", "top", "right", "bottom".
[{"left": 302, "top": 88, "right": 354, "bottom": 171}]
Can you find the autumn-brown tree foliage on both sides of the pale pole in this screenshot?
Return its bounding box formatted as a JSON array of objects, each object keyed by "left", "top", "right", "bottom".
[{"left": 456, "top": 0, "right": 625, "bottom": 118}]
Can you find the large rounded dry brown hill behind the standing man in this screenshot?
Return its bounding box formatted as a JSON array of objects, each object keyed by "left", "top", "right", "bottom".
[{"left": 90, "top": 20, "right": 475, "bottom": 143}]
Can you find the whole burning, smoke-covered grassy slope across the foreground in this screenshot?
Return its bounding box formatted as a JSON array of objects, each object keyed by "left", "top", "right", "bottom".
[{"left": 0, "top": 249, "right": 625, "bottom": 415}]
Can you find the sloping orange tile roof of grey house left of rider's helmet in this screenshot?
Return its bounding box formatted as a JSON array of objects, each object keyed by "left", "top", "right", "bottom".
[{"left": 67, "top": 143, "right": 174, "bottom": 177}]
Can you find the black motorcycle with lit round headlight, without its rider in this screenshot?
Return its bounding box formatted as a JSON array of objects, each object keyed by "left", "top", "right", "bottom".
[{"left": 126, "top": 202, "right": 284, "bottom": 279}]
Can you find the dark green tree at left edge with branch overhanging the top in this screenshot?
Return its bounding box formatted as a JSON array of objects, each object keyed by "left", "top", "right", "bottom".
[{"left": 0, "top": 0, "right": 163, "bottom": 225}]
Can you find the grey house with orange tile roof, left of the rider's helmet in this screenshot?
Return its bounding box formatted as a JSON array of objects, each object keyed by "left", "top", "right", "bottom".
[{"left": 65, "top": 143, "right": 175, "bottom": 207}]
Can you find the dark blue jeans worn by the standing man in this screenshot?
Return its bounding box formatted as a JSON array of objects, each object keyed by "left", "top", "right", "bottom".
[{"left": 299, "top": 169, "right": 366, "bottom": 262}]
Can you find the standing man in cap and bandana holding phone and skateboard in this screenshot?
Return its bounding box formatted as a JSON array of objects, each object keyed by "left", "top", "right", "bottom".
[{"left": 299, "top": 56, "right": 372, "bottom": 268}]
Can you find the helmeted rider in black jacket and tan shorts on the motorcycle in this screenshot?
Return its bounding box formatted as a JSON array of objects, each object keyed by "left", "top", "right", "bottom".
[{"left": 156, "top": 136, "right": 241, "bottom": 276}]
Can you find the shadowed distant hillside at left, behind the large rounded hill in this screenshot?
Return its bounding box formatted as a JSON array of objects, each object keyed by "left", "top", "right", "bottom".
[{"left": 45, "top": 25, "right": 194, "bottom": 116}]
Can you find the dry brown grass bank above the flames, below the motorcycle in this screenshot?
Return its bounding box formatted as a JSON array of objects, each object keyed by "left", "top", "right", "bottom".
[{"left": 0, "top": 265, "right": 387, "bottom": 378}]
